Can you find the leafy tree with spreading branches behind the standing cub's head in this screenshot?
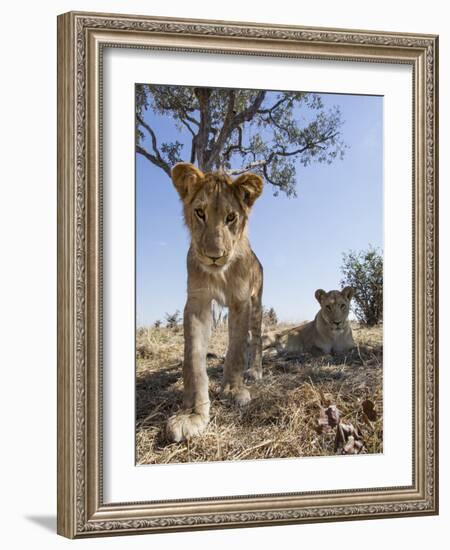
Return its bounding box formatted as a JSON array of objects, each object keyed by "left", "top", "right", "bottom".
[{"left": 136, "top": 84, "right": 345, "bottom": 196}]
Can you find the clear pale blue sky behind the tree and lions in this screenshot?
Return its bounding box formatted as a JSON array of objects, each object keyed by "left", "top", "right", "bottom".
[{"left": 136, "top": 88, "right": 383, "bottom": 326}]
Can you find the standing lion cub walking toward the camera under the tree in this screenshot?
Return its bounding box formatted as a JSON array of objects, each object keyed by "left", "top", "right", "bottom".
[{"left": 167, "top": 163, "right": 263, "bottom": 441}]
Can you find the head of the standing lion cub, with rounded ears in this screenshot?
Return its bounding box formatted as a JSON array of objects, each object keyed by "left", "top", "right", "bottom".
[{"left": 172, "top": 163, "right": 263, "bottom": 273}]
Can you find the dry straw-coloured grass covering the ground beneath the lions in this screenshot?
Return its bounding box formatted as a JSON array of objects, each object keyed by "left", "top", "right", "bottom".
[{"left": 136, "top": 325, "right": 383, "bottom": 464}]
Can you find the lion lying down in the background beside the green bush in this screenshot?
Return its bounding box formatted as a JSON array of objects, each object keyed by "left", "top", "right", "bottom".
[{"left": 264, "top": 286, "right": 355, "bottom": 354}]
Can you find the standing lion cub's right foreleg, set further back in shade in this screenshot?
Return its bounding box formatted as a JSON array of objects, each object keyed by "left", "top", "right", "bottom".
[{"left": 222, "top": 300, "right": 251, "bottom": 406}]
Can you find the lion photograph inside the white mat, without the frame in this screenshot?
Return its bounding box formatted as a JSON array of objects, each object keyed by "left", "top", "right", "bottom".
[{"left": 135, "top": 82, "right": 384, "bottom": 465}]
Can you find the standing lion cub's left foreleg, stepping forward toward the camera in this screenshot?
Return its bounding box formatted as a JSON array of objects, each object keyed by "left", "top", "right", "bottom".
[{"left": 167, "top": 297, "right": 211, "bottom": 442}]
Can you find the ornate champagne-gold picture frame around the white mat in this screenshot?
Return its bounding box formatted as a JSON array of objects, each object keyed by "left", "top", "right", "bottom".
[{"left": 58, "top": 12, "right": 438, "bottom": 538}]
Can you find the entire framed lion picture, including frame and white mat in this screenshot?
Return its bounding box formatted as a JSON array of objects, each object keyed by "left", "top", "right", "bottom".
[{"left": 58, "top": 12, "right": 438, "bottom": 538}]
